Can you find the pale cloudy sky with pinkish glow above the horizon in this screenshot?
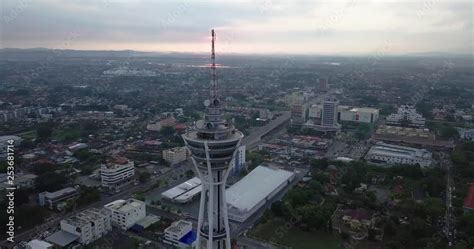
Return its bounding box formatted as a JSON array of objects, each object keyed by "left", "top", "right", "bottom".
[{"left": 0, "top": 0, "right": 474, "bottom": 54}]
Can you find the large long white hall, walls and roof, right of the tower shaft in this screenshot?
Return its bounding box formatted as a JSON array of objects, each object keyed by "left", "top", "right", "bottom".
[{"left": 226, "top": 166, "right": 295, "bottom": 222}]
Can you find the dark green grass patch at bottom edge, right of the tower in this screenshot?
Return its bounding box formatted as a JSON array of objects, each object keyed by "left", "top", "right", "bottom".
[{"left": 250, "top": 219, "right": 340, "bottom": 249}]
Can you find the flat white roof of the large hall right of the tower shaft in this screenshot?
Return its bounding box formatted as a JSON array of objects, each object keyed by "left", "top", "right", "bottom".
[{"left": 226, "top": 166, "right": 294, "bottom": 212}]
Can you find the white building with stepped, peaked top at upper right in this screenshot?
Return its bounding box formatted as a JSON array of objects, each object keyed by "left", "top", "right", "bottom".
[{"left": 386, "top": 105, "right": 425, "bottom": 127}]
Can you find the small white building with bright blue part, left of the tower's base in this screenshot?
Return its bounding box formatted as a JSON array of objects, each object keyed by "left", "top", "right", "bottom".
[{"left": 163, "top": 220, "right": 196, "bottom": 248}]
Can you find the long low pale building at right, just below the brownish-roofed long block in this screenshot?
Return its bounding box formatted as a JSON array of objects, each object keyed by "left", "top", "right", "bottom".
[{"left": 365, "top": 142, "right": 432, "bottom": 167}]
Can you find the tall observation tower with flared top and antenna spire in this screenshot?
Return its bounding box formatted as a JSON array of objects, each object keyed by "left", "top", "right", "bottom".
[{"left": 183, "top": 30, "right": 244, "bottom": 249}]
